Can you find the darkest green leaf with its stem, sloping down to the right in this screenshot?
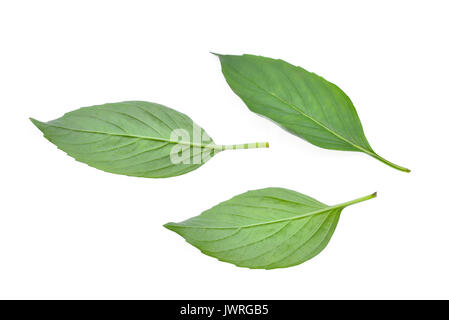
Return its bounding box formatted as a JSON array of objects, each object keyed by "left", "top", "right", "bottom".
[{"left": 217, "top": 55, "right": 410, "bottom": 172}]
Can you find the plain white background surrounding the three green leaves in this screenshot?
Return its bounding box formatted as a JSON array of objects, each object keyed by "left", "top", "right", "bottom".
[{"left": 0, "top": 0, "right": 449, "bottom": 299}]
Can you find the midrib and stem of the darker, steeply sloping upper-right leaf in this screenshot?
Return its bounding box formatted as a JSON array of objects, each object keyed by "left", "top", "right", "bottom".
[{"left": 222, "top": 65, "right": 410, "bottom": 172}]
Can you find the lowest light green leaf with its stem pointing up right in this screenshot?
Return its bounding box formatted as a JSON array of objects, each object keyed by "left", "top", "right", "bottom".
[{"left": 165, "top": 188, "right": 376, "bottom": 269}]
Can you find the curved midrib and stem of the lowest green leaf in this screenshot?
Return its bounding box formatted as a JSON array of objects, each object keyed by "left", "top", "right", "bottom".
[{"left": 166, "top": 192, "right": 377, "bottom": 229}]
